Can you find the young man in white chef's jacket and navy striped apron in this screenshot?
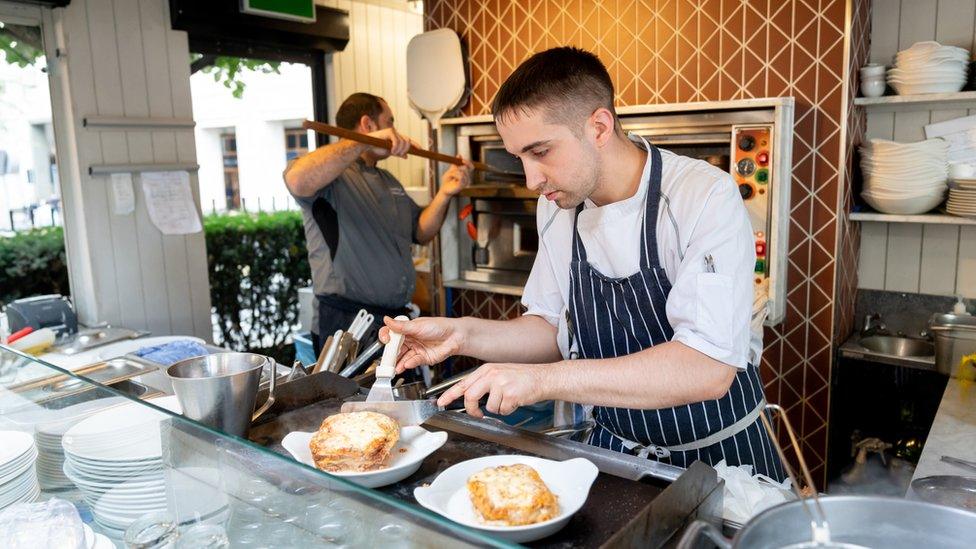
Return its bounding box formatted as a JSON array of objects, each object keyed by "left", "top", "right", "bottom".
[{"left": 381, "top": 47, "right": 784, "bottom": 479}]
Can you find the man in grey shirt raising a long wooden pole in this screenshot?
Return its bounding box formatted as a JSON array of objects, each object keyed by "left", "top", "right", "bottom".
[{"left": 284, "top": 93, "right": 471, "bottom": 355}]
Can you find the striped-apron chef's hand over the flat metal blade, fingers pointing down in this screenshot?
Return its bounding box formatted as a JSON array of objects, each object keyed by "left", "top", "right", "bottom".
[{"left": 437, "top": 364, "right": 545, "bottom": 418}]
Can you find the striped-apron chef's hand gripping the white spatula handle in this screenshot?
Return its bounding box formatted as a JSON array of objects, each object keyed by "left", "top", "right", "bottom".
[{"left": 379, "top": 316, "right": 464, "bottom": 374}]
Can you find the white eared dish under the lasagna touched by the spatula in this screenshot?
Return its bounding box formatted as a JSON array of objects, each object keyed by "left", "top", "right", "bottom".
[{"left": 281, "top": 426, "right": 447, "bottom": 488}]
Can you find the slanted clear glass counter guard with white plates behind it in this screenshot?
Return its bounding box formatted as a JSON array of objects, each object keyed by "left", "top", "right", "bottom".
[{"left": 0, "top": 345, "right": 516, "bottom": 548}]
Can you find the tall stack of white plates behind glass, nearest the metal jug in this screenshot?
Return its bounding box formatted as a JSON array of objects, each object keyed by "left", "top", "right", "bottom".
[{"left": 61, "top": 396, "right": 180, "bottom": 533}]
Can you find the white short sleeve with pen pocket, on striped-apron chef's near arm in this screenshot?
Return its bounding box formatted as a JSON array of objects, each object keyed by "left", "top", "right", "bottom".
[{"left": 666, "top": 180, "right": 756, "bottom": 368}]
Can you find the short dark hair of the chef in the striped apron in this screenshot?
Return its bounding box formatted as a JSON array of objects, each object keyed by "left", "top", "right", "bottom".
[{"left": 491, "top": 46, "right": 619, "bottom": 131}]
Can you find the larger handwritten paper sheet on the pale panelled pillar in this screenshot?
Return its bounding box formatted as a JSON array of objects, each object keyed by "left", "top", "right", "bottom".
[{"left": 142, "top": 171, "right": 203, "bottom": 234}]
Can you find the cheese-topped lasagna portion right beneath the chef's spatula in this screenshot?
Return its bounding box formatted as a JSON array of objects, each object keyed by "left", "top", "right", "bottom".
[{"left": 309, "top": 412, "right": 400, "bottom": 473}]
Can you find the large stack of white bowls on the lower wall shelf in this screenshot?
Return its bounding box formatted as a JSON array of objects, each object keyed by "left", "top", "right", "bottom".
[{"left": 861, "top": 139, "right": 949, "bottom": 214}]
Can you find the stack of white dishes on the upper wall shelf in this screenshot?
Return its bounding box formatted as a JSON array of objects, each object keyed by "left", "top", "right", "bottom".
[{"left": 888, "top": 42, "right": 969, "bottom": 95}]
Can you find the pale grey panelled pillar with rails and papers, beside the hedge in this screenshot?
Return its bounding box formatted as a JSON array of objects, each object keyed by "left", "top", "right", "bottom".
[{"left": 52, "top": 0, "right": 212, "bottom": 340}]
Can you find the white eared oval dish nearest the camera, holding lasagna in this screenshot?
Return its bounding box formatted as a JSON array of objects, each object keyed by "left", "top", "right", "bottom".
[{"left": 413, "top": 455, "right": 599, "bottom": 543}]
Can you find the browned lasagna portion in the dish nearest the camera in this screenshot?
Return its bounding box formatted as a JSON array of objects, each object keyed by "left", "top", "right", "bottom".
[{"left": 468, "top": 463, "right": 559, "bottom": 526}]
